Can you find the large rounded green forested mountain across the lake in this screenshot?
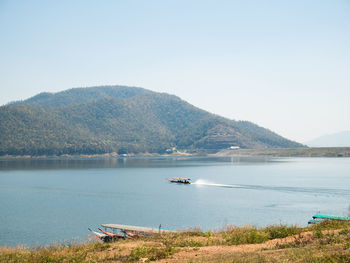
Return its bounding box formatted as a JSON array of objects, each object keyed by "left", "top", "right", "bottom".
[{"left": 0, "top": 86, "right": 302, "bottom": 155}]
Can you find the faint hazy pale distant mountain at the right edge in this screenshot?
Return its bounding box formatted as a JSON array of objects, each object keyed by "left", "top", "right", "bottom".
[{"left": 305, "top": 131, "right": 350, "bottom": 147}]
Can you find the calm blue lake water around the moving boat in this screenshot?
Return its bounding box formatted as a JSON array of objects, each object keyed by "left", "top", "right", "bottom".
[{"left": 0, "top": 157, "right": 350, "bottom": 246}]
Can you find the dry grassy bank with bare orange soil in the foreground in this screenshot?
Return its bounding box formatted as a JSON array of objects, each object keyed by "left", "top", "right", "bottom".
[{"left": 0, "top": 221, "right": 350, "bottom": 262}]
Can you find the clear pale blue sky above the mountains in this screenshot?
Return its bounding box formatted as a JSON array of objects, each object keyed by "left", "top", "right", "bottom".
[{"left": 0, "top": 0, "right": 350, "bottom": 142}]
